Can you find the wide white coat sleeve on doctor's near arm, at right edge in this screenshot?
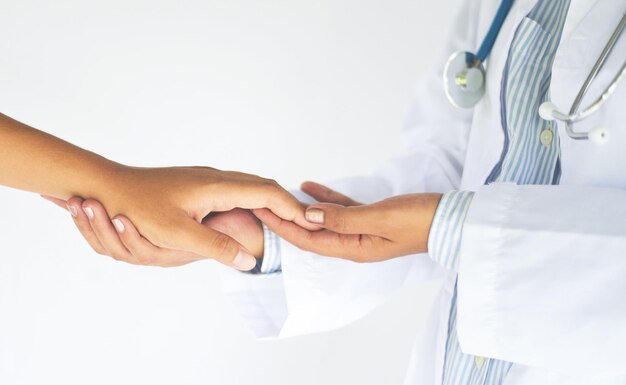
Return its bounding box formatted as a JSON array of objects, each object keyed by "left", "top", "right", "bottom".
[{"left": 457, "top": 184, "right": 626, "bottom": 374}]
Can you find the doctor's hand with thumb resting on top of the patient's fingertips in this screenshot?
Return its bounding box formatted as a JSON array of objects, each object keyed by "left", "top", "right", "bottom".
[{"left": 253, "top": 182, "right": 441, "bottom": 262}]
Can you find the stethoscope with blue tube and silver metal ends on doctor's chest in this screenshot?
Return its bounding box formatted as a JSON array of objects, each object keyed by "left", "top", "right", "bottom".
[{"left": 443, "top": 0, "right": 626, "bottom": 144}]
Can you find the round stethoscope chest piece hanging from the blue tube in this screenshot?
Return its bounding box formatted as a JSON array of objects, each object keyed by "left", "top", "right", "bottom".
[{"left": 443, "top": 51, "right": 485, "bottom": 108}]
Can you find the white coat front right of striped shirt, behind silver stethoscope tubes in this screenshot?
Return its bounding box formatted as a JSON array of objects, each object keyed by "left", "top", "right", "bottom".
[{"left": 550, "top": 0, "right": 626, "bottom": 186}]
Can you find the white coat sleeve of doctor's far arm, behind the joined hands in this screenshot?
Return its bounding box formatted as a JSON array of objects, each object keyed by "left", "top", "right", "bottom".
[{"left": 217, "top": 0, "right": 480, "bottom": 336}]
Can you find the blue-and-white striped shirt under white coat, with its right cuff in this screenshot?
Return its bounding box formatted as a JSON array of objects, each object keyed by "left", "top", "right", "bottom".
[{"left": 428, "top": 0, "right": 570, "bottom": 385}]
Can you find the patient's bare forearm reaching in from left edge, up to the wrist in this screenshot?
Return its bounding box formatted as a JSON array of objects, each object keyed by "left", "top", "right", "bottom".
[{"left": 0, "top": 114, "right": 122, "bottom": 199}]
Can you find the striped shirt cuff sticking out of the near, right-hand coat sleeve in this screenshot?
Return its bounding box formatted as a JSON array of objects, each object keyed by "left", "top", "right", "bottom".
[{"left": 428, "top": 191, "right": 474, "bottom": 271}]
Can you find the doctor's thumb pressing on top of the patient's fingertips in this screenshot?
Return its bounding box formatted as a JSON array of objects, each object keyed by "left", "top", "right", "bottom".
[{"left": 305, "top": 203, "right": 380, "bottom": 235}]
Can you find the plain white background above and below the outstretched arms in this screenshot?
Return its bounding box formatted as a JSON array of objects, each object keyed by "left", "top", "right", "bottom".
[{"left": 0, "top": 0, "right": 454, "bottom": 385}]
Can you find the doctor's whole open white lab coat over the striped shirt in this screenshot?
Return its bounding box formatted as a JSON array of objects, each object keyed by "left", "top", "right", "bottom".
[{"left": 218, "top": 0, "right": 626, "bottom": 385}]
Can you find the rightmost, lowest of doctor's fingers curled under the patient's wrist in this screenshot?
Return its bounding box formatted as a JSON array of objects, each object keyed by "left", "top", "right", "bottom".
[{"left": 111, "top": 215, "right": 201, "bottom": 267}]
